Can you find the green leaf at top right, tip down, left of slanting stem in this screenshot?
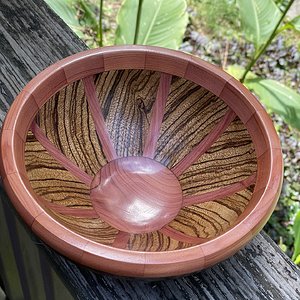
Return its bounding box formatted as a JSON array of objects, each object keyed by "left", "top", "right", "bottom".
[{"left": 237, "top": 0, "right": 281, "bottom": 50}]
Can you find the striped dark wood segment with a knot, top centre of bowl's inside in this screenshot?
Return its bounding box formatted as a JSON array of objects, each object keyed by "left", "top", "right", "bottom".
[{"left": 95, "top": 70, "right": 160, "bottom": 157}]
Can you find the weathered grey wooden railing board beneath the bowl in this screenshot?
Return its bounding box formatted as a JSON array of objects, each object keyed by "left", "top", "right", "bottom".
[{"left": 0, "top": 0, "right": 300, "bottom": 299}]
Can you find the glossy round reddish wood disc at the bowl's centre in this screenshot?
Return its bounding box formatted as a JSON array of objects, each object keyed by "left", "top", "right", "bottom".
[{"left": 91, "top": 157, "right": 182, "bottom": 233}]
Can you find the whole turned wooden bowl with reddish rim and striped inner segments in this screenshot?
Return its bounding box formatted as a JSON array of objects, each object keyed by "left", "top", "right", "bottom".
[{"left": 1, "top": 46, "right": 282, "bottom": 278}]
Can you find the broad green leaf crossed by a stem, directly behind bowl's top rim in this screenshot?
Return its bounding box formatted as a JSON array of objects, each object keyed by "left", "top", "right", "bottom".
[{"left": 115, "top": 0, "right": 188, "bottom": 49}]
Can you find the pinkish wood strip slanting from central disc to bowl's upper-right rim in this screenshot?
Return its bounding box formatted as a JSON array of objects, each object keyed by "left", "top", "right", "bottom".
[{"left": 171, "top": 108, "right": 236, "bottom": 177}]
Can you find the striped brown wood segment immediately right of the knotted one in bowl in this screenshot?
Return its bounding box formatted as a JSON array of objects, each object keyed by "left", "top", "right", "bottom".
[{"left": 155, "top": 76, "right": 228, "bottom": 168}]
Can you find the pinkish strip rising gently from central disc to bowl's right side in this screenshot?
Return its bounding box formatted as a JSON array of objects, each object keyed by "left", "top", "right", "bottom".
[{"left": 182, "top": 173, "right": 256, "bottom": 206}]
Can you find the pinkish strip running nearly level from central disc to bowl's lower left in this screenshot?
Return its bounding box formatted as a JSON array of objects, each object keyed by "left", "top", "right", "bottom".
[{"left": 39, "top": 197, "right": 99, "bottom": 218}]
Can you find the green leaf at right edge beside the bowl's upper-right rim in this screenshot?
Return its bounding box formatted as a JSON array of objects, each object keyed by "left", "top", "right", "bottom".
[{"left": 245, "top": 78, "right": 300, "bottom": 129}]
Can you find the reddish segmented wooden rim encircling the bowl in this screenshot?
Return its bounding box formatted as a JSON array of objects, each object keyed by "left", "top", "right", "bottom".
[{"left": 0, "top": 45, "right": 283, "bottom": 277}]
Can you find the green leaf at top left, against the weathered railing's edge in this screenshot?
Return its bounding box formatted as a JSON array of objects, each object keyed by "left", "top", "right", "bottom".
[{"left": 45, "top": 0, "right": 83, "bottom": 38}]
